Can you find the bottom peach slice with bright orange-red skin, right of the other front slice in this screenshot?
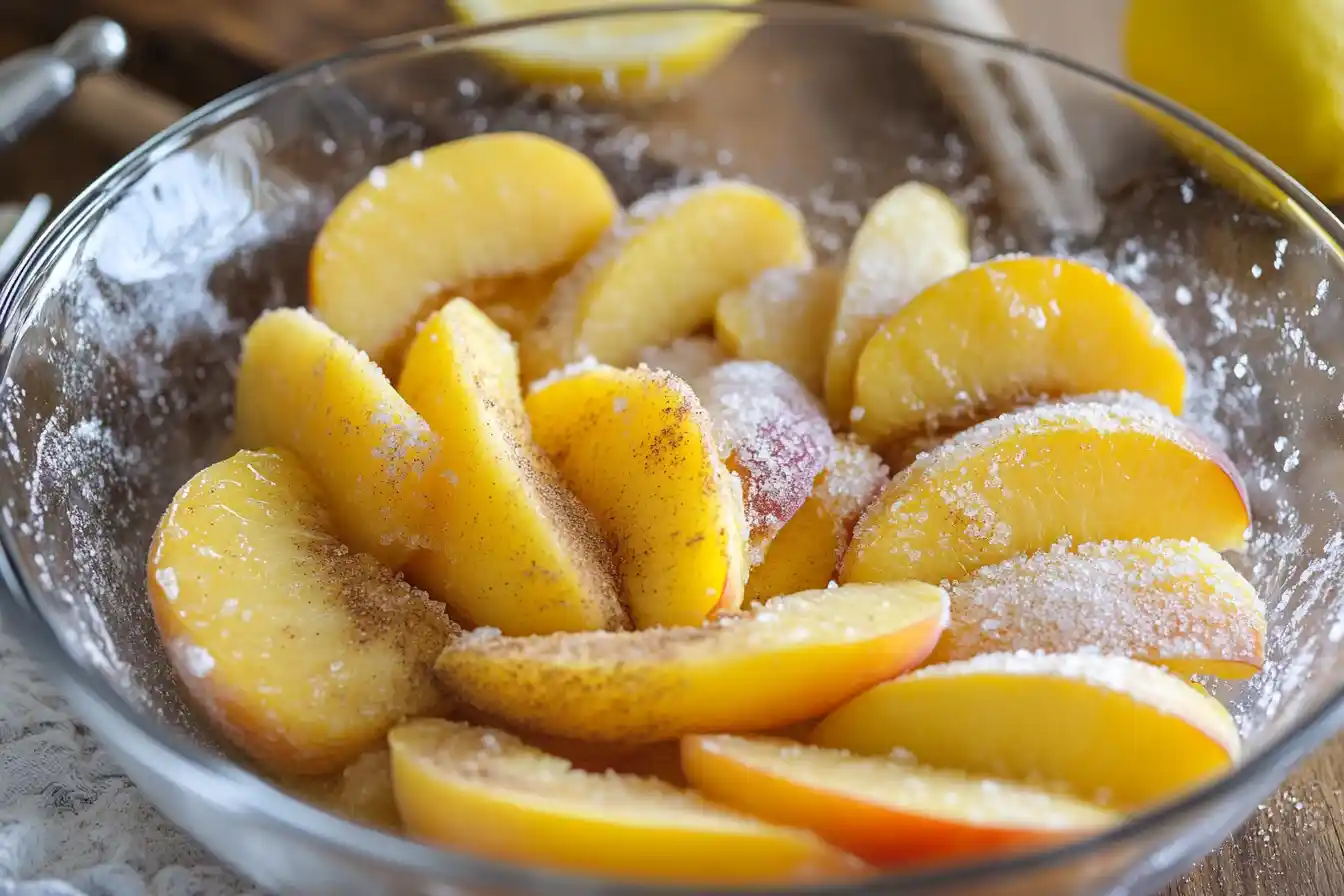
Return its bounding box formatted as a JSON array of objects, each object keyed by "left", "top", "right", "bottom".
[{"left": 681, "top": 735, "right": 1121, "bottom": 868}]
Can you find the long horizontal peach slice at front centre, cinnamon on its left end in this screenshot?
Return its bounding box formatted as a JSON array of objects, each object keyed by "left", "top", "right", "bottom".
[{"left": 437, "top": 582, "right": 948, "bottom": 743}]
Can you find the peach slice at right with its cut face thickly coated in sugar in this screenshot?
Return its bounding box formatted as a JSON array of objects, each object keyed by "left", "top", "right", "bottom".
[{"left": 929, "top": 539, "right": 1265, "bottom": 678}]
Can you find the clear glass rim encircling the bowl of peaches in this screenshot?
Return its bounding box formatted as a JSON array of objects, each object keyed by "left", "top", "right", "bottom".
[{"left": 0, "top": 0, "right": 1344, "bottom": 895}]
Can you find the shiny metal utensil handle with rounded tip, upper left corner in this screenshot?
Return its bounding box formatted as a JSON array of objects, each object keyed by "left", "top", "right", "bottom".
[{"left": 0, "top": 19, "right": 126, "bottom": 152}]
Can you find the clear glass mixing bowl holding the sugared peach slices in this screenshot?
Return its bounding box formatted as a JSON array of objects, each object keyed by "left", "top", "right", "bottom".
[{"left": 0, "top": 5, "right": 1344, "bottom": 896}]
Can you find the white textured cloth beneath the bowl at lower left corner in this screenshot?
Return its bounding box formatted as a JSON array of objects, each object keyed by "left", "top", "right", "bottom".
[{"left": 0, "top": 630, "right": 259, "bottom": 896}]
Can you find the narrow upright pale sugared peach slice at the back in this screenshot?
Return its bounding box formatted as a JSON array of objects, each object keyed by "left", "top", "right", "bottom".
[{"left": 823, "top": 181, "right": 970, "bottom": 424}]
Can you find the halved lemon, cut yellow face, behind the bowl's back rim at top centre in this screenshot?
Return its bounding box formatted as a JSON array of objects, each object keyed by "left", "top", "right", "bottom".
[{"left": 448, "top": 0, "right": 759, "bottom": 98}]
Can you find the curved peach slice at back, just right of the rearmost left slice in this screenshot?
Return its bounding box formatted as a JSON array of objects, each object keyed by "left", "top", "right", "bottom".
[{"left": 527, "top": 181, "right": 812, "bottom": 371}]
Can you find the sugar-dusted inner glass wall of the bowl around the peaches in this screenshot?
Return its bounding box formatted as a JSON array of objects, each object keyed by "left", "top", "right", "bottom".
[{"left": 0, "top": 3, "right": 1344, "bottom": 891}]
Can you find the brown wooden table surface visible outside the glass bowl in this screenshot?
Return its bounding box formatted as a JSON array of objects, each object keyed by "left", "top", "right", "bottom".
[{"left": 0, "top": 0, "right": 1344, "bottom": 896}]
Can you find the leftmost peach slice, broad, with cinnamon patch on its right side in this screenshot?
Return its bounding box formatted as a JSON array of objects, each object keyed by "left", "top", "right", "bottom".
[{"left": 148, "top": 451, "right": 457, "bottom": 775}]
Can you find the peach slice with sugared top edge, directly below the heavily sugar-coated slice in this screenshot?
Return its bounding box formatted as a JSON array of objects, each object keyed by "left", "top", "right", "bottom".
[{"left": 812, "top": 653, "right": 1241, "bottom": 810}]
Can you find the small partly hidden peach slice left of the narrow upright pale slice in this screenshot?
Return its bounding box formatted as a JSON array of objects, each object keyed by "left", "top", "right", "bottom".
[{"left": 714, "top": 266, "right": 841, "bottom": 395}]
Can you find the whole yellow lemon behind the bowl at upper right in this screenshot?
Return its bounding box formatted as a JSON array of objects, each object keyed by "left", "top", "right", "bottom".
[{"left": 1125, "top": 0, "right": 1344, "bottom": 201}]
